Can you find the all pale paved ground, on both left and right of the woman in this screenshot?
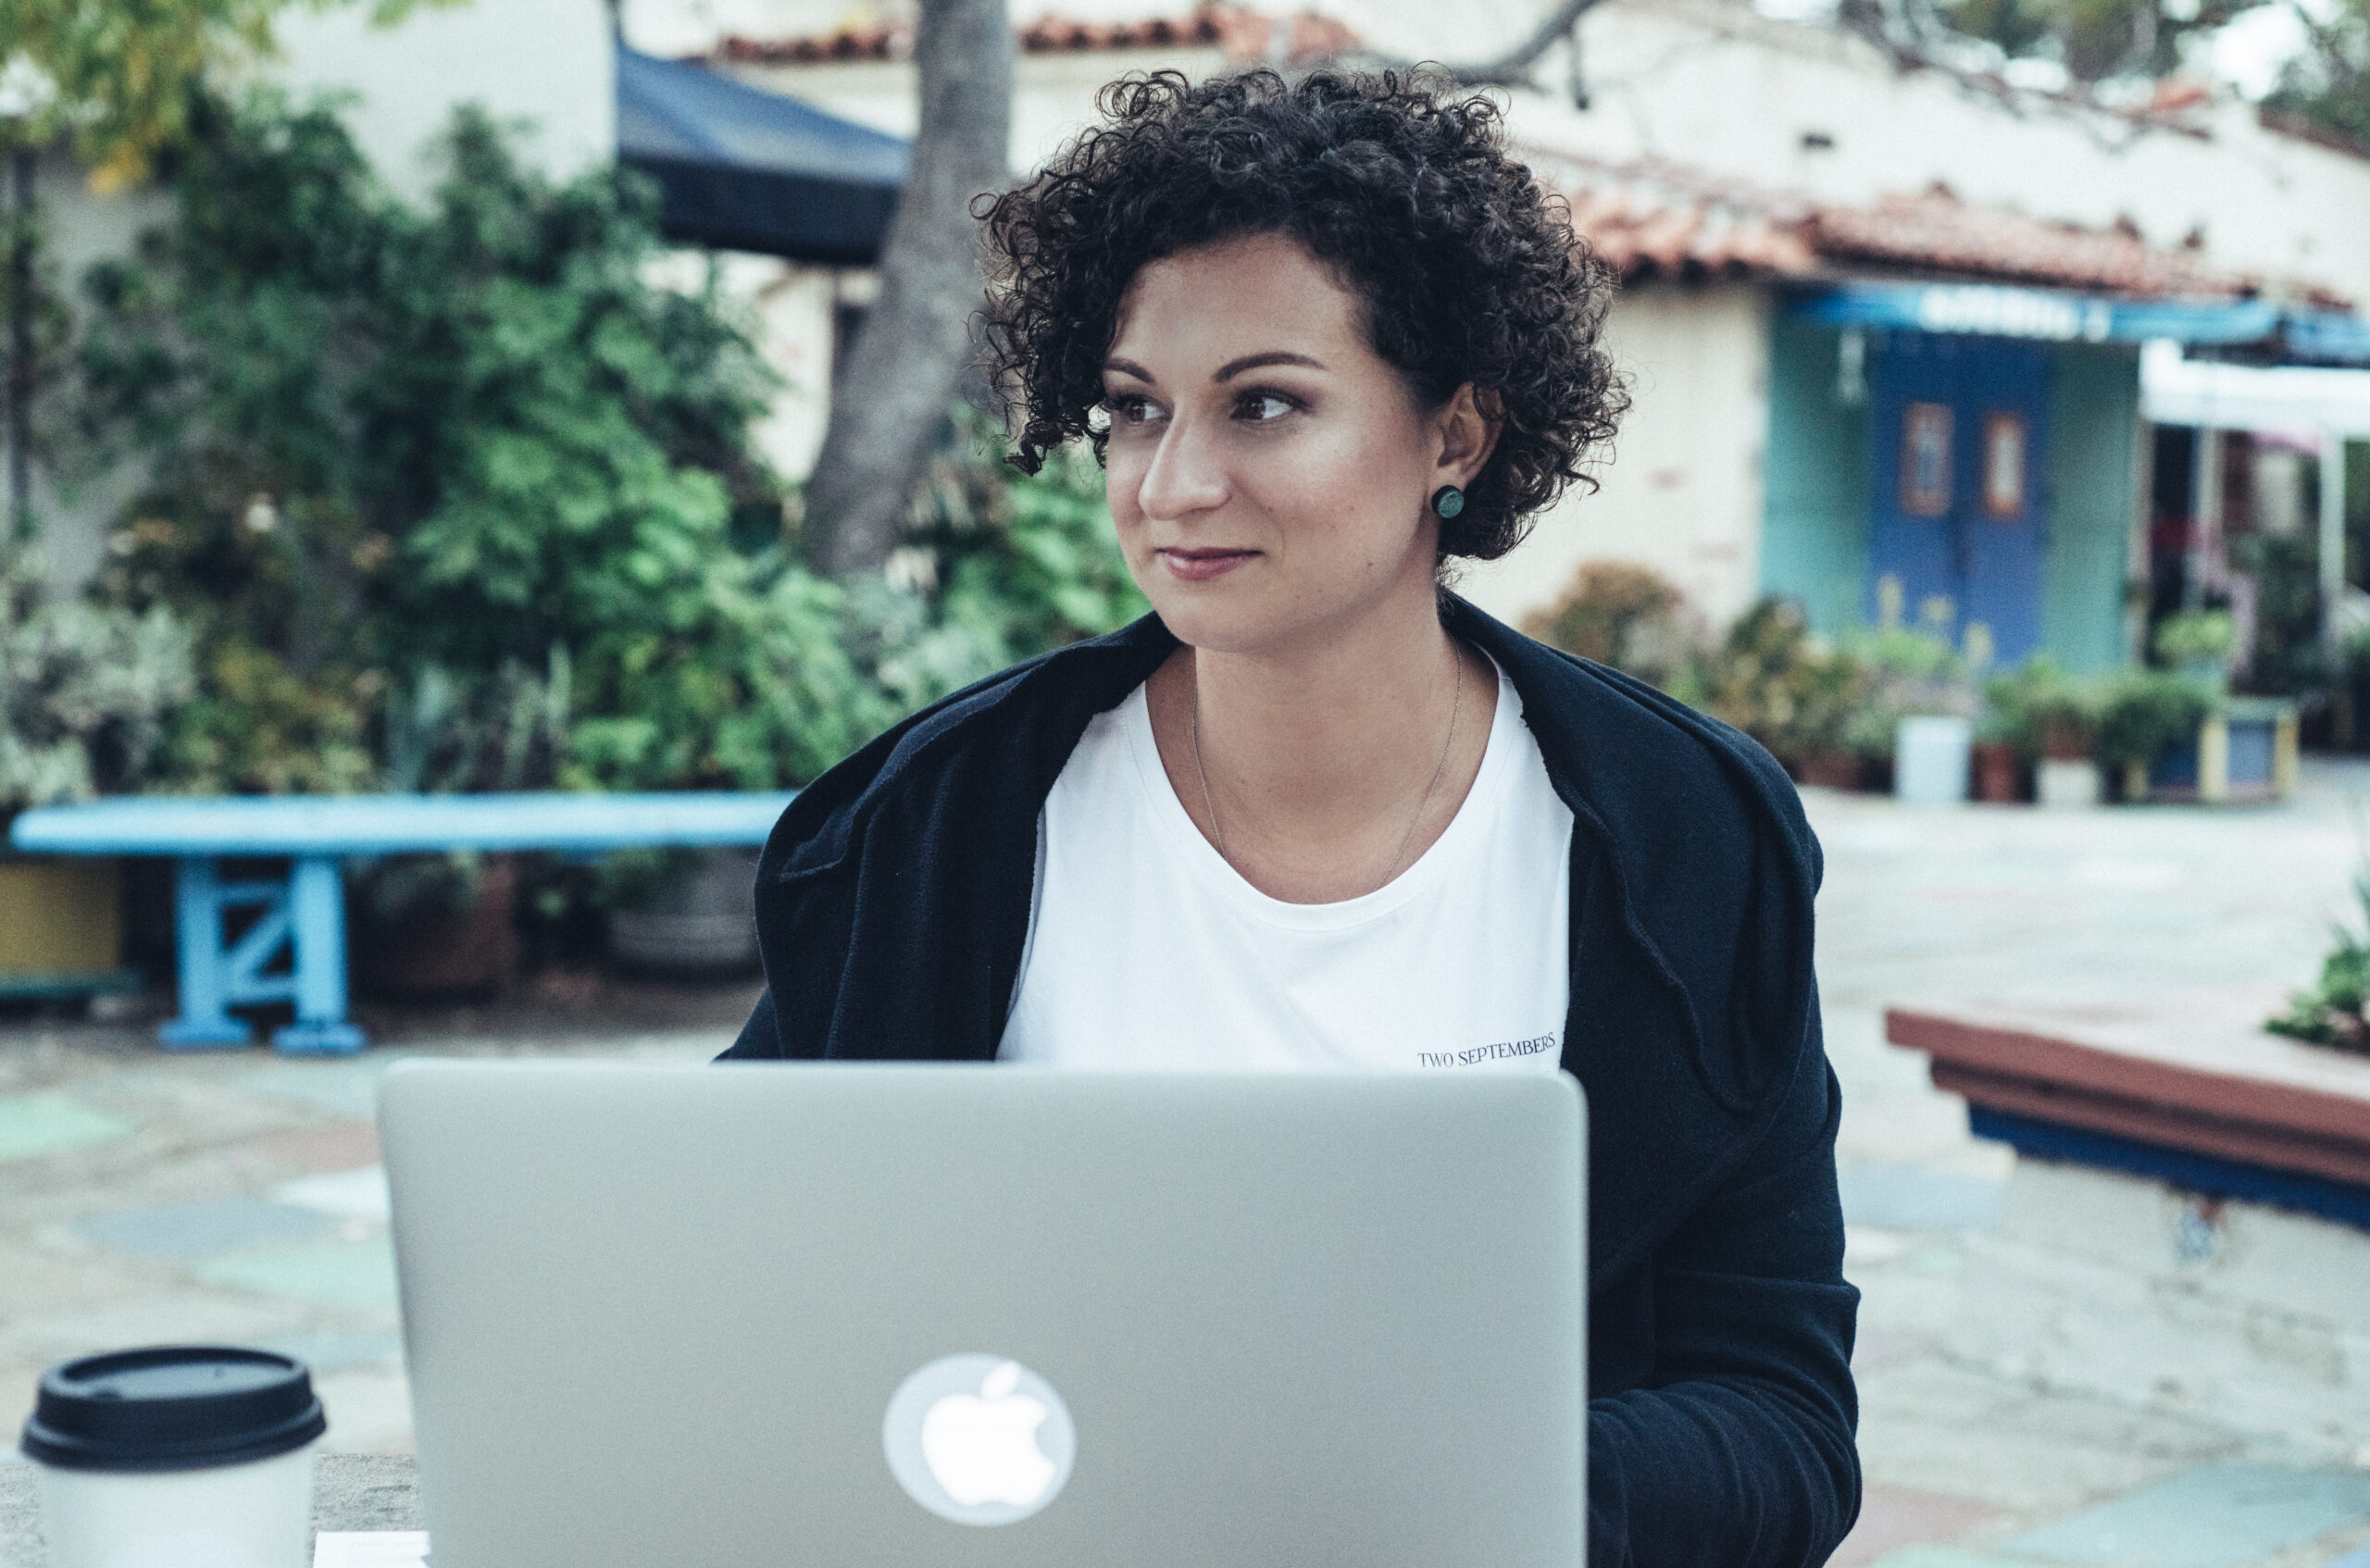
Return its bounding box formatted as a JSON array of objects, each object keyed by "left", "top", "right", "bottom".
[{"left": 0, "top": 763, "right": 2370, "bottom": 1568}]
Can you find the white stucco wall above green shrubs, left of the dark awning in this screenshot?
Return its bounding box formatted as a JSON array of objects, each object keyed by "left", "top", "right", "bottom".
[{"left": 270, "top": 0, "right": 617, "bottom": 199}]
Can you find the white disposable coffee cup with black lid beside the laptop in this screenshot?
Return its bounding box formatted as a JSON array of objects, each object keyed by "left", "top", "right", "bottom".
[{"left": 24, "top": 1345, "right": 330, "bottom": 1568}]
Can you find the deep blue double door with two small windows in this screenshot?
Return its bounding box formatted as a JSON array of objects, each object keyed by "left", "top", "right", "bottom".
[{"left": 1865, "top": 331, "right": 2050, "bottom": 666}]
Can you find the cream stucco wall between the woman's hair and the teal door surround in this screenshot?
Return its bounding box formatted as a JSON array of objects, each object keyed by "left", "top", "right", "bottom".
[{"left": 1460, "top": 284, "right": 1768, "bottom": 628}]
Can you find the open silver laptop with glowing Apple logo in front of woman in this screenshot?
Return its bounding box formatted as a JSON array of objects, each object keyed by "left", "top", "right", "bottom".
[{"left": 380, "top": 1061, "right": 1586, "bottom": 1568}]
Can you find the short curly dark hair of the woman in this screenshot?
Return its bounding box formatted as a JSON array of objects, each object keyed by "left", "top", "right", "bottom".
[{"left": 981, "top": 68, "right": 1628, "bottom": 561}]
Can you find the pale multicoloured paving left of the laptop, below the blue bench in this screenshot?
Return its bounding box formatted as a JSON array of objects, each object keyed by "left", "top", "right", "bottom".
[{"left": 0, "top": 978, "right": 756, "bottom": 1452}]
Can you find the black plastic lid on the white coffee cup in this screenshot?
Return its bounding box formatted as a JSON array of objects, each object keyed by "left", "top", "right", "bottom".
[{"left": 24, "top": 1345, "right": 330, "bottom": 1471}]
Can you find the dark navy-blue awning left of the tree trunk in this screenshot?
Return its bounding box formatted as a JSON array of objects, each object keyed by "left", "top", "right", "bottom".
[{"left": 617, "top": 45, "right": 913, "bottom": 266}]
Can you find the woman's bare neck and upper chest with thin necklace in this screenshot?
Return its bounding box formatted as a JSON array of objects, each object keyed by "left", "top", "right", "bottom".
[{"left": 1147, "top": 592, "right": 1498, "bottom": 902}]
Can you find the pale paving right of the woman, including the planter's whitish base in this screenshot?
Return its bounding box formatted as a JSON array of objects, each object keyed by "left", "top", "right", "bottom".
[{"left": 1806, "top": 763, "right": 2370, "bottom": 1568}]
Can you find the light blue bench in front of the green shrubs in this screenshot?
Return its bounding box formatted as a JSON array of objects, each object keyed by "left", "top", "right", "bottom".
[{"left": 9, "top": 791, "right": 792, "bottom": 1056}]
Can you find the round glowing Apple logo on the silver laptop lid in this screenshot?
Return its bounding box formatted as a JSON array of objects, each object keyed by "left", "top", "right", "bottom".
[{"left": 881, "top": 1355, "right": 1079, "bottom": 1525}]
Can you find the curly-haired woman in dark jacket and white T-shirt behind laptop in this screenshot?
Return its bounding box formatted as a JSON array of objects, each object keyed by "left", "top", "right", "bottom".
[{"left": 730, "top": 73, "right": 1858, "bottom": 1568}]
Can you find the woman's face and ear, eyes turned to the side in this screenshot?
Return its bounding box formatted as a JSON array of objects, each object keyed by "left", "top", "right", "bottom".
[{"left": 1102, "top": 234, "right": 1491, "bottom": 653}]
